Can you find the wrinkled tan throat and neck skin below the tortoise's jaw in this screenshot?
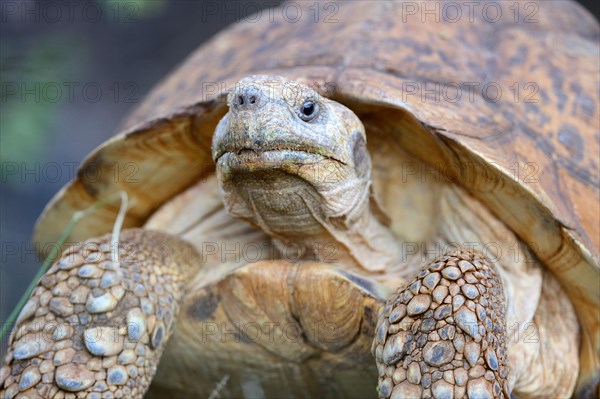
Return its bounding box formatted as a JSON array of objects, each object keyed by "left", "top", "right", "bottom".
[{"left": 218, "top": 163, "right": 402, "bottom": 272}]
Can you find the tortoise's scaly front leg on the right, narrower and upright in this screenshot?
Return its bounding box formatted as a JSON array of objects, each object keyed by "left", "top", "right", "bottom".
[{"left": 373, "top": 250, "right": 510, "bottom": 398}]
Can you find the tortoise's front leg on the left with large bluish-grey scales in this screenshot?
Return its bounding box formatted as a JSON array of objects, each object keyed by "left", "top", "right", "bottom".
[{"left": 0, "top": 229, "right": 200, "bottom": 398}]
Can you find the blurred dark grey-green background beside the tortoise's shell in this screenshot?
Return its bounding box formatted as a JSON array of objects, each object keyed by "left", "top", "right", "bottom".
[{"left": 0, "top": 0, "right": 599, "bottom": 338}]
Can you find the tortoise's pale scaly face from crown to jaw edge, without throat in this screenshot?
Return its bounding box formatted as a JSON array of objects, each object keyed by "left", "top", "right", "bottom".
[{"left": 212, "top": 76, "right": 370, "bottom": 190}]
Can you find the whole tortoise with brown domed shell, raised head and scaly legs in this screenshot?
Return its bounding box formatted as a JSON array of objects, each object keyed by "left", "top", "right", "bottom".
[{"left": 0, "top": 1, "right": 600, "bottom": 398}]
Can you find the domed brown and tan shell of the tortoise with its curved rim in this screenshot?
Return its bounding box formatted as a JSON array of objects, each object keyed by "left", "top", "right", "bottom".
[{"left": 35, "top": 1, "right": 600, "bottom": 396}]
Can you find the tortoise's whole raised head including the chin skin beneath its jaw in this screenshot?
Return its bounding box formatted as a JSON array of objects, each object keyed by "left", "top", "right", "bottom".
[{"left": 212, "top": 76, "right": 371, "bottom": 239}]
